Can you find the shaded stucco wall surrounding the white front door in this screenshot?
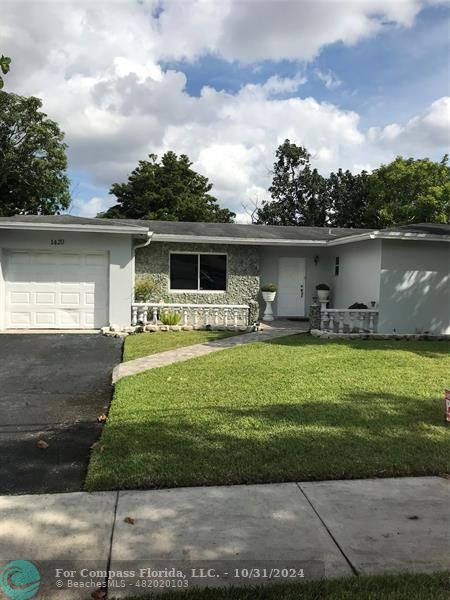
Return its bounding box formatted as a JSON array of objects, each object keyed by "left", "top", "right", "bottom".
[{"left": 260, "top": 246, "right": 331, "bottom": 317}]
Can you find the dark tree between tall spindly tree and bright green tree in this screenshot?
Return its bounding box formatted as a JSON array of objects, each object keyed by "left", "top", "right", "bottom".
[{"left": 327, "top": 169, "right": 376, "bottom": 227}]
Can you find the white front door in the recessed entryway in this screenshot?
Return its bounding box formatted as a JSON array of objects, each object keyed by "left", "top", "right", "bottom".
[{"left": 277, "top": 256, "right": 305, "bottom": 317}]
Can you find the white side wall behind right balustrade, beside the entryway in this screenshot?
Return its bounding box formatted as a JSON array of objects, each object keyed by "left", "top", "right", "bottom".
[{"left": 329, "top": 240, "right": 381, "bottom": 308}]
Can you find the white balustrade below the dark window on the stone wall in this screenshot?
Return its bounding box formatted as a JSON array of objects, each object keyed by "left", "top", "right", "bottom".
[{"left": 131, "top": 302, "right": 249, "bottom": 328}]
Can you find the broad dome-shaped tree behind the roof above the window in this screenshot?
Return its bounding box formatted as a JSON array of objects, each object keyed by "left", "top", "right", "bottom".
[{"left": 99, "top": 152, "right": 235, "bottom": 223}]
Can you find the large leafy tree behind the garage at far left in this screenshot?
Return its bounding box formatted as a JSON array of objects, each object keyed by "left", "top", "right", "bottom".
[{"left": 0, "top": 91, "right": 70, "bottom": 216}]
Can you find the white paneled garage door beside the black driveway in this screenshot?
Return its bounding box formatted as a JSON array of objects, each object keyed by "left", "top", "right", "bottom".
[{"left": 5, "top": 251, "right": 108, "bottom": 329}]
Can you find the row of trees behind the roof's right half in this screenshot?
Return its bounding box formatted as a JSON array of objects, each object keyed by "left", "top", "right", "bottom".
[{"left": 255, "top": 140, "right": 450, "bottom": 228}]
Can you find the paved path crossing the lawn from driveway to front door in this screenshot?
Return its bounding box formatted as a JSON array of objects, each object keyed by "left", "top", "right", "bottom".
[{"left": 113, "top": 321, "right": 309, "bottom": 383}]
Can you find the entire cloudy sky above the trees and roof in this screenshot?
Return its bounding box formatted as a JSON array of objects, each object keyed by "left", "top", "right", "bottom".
[{"left": 0, "top": 0, "right": 450, "bottom": 220}]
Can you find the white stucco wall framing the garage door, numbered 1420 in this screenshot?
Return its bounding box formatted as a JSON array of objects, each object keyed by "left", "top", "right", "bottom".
[{"left": 0, "top": 229, "right": 134, "bottom": 329}]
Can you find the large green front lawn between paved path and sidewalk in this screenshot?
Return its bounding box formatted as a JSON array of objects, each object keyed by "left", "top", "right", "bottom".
[{"left": 86, "top": 335, "right": 450, "bottom": 490}]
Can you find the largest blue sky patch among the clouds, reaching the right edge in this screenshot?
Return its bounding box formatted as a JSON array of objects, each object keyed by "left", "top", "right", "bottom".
[{"left": 162, "top": 5, "right": 450, "bottom": 126}]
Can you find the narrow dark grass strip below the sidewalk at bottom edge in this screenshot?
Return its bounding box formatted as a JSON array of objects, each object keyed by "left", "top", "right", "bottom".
[{"left": 113, "top": 572, "right": 450, "bottom": 600}]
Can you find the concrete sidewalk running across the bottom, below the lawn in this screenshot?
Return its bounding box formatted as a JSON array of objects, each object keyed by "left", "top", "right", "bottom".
[{"left": 0, "top": 477, "right": 450, "bottom": 599}]
